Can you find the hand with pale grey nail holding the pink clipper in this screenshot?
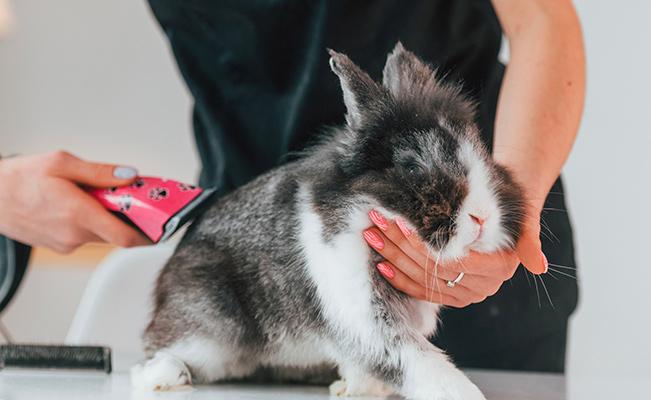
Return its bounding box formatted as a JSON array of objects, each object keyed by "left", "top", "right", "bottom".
[{"left": 0, "top": 151, "right": 151, "bottom": 253}]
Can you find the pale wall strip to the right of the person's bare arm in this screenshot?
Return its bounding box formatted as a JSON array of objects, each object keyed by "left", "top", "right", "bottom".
[{"left": 565, "top": 0, "right": 651, "bottom": 400}]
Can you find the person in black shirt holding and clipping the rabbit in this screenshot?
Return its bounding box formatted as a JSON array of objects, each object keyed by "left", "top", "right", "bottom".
[{"left": 0, "top": 0, "right": 585, "bottom": 371}]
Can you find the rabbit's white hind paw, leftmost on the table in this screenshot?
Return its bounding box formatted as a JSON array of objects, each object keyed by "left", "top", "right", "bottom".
[{"left": 131, "top": 351, "right": 192, "bottom": 390}]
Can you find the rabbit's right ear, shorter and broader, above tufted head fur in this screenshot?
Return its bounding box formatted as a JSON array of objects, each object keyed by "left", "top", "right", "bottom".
[{"left": 382, "top": 42, "right": 437, "bottom": 98}]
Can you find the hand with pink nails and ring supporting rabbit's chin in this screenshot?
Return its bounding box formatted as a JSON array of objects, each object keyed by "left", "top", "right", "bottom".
[{"left": 364, "top": 210, "right": 547, "bottom": 307}]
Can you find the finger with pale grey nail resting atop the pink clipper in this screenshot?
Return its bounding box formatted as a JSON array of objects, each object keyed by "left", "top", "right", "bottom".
[{"left": 47, "top": 152, "right": 138, "bottom": 187}]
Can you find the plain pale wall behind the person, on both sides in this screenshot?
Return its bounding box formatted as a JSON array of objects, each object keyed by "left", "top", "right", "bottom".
[{"left": 0, "top": 0, "right": 651, "bottom": 399}]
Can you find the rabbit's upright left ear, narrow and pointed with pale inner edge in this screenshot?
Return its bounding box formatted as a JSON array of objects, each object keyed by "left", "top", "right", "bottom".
[{"left": 328, "top": 49, "right": 385, "bottom": 129}]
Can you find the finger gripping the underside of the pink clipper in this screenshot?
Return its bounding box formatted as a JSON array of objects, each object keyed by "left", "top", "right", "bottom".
[{"left": 79, "top": 197, "right": 151, "bottom": 247}]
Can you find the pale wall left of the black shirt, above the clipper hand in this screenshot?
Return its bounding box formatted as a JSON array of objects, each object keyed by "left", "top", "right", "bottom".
[{"left": 0, "top": 0, "right": 198, "bottom": 182}]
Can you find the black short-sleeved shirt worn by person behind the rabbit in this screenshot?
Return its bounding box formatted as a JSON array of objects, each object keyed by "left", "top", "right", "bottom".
[{"left": 150, "top": 0, "right": 577, "bottom": 371}]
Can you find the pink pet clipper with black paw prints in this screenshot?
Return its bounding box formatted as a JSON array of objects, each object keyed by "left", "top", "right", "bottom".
[{"left": 88, "top": 177, "right": 215, "bottom": 243}]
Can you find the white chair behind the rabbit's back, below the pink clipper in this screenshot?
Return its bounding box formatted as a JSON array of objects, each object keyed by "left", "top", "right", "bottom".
[{"left": 66, "top": 243, "right": 176, "bottom": 371}]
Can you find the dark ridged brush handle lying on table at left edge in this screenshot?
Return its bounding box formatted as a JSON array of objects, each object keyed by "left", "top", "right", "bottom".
[{"left": 0, "top": 344, "right": 111, "bottom": 374}]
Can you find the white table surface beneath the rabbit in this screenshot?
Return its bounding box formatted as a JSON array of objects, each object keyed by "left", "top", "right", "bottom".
[{"left": 0, "top": 370, "right": 565, "bottom": 400}]
